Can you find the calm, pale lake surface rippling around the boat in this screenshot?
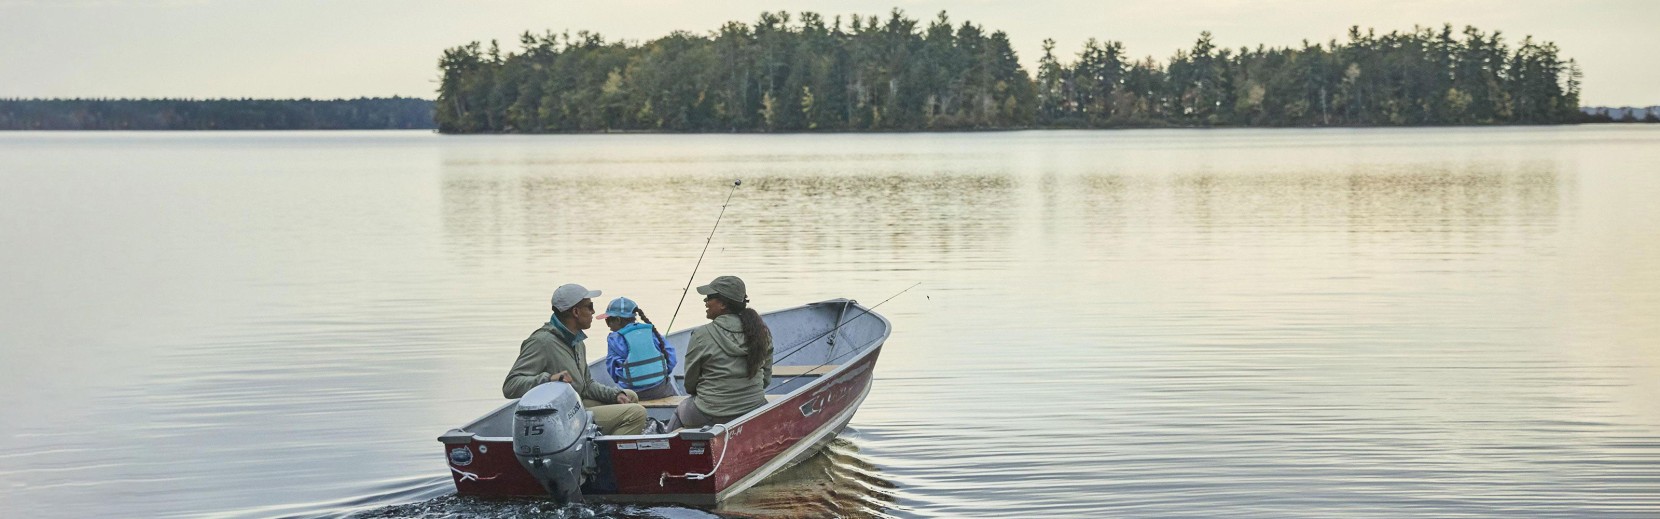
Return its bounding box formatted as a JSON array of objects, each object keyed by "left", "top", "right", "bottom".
[{"left": 0, "top": 124, "right": 1660, "bottom": 517}]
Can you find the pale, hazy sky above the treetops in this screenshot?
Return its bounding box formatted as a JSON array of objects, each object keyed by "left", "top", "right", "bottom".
[{"left": 0, "top": 0, "right": 1660, "bottom": 106}]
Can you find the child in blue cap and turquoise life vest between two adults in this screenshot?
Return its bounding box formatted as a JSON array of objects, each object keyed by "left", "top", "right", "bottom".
[{"left": 598, "top": 297, "right": 679, "bottom": 400}]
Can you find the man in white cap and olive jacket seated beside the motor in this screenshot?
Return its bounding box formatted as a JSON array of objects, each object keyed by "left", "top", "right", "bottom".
[{"left": 501, "top": 284, "right": 646, "bottom": 434}]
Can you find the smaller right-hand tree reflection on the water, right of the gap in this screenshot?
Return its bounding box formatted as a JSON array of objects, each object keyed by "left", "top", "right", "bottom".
[{"left": 1051, "top": 164, "right": 1570, "bottom": 232}]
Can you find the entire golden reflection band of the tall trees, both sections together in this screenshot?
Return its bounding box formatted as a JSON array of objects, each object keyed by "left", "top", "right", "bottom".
[{"left": 443, "top": 164, "right": 1572, "bottom": 265}]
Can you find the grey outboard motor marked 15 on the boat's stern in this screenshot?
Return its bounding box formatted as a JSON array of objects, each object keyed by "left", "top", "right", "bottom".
[{"left": 513, "top": 381, "right": 599, "bottom": 504}]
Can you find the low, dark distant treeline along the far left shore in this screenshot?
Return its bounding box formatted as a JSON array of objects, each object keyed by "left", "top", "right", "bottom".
[{"left": 0, "top": 98, "right": 435, "bottom": 129}]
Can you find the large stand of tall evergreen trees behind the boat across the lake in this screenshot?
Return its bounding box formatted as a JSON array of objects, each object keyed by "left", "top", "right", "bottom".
[{"left": 435, "top": 10, "right": 1580, "bottom": 133}]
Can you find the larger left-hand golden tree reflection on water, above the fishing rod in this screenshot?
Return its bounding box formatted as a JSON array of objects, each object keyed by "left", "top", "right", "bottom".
[{"left": 443, "top": 174, "right": 1018, "bottom": 261}]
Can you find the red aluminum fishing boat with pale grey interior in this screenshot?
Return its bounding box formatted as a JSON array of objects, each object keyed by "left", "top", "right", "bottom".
[{"left": 438, "top": 298, "right": 890, "bottom": 506}]
